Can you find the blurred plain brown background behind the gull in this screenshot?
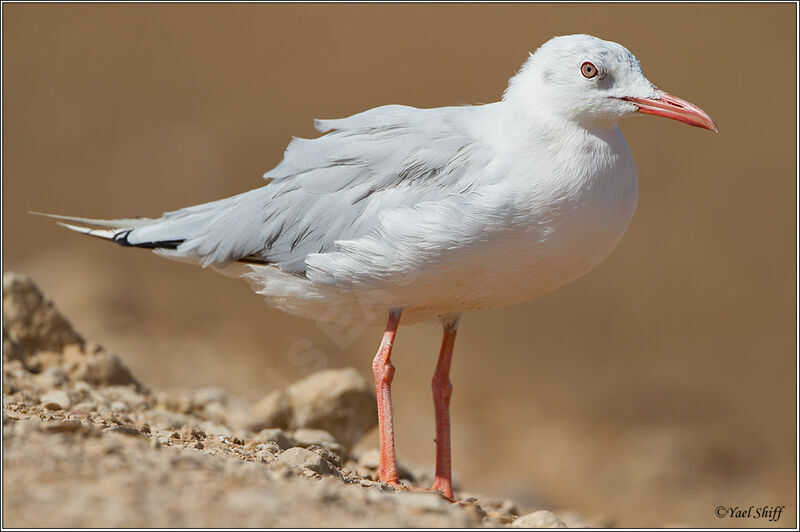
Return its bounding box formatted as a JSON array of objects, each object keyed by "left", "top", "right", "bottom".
[{"left": 3, "top": 4, "right": 797, "bottom": 526}]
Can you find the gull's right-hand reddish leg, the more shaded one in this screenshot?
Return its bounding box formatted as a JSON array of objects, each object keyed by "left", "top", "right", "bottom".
[{"left": 431, "top": 314, "right": 461, "bottom": 499}]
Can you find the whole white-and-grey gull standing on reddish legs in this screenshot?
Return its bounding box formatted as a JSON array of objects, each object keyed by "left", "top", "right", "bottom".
[{"left": 39, "top": 35, "right": 717, "bottom": 498}]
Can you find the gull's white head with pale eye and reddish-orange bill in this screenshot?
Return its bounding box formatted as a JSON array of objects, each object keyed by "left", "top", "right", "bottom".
[{"left": 503, "top": 35, "right": 717, "bottom": 131}]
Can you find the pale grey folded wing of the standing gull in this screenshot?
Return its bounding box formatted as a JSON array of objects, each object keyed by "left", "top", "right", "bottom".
[{"left": 87, "top": 105, "right": 490, "bottom": 273}]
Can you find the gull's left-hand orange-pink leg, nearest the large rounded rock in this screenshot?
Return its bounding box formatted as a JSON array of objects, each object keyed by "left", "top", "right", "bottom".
[{"left": 372, "top": 310, "right": 402, "bottom": 486}]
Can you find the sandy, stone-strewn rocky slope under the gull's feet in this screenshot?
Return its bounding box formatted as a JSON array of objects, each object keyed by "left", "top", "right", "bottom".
[{"left": 3, "top": 273, "right": 589, "bottom": 527}]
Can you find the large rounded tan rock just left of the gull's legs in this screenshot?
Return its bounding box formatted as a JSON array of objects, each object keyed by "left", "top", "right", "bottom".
[{"left": 287, "top": 368, "right": 378, "bottom": 449}]
